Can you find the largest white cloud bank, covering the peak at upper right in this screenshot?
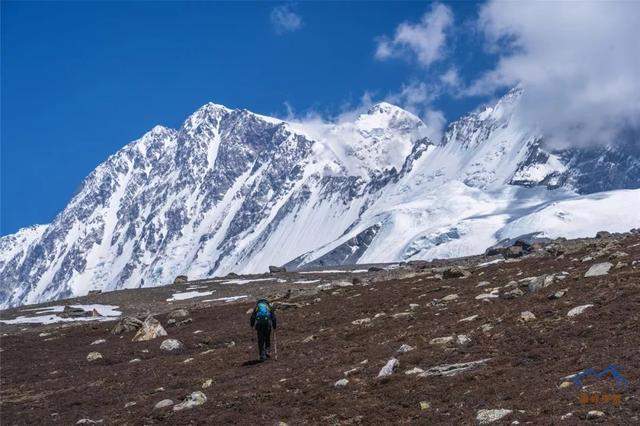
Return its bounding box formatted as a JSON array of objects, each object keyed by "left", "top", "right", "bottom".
[{"left": 466, "top": 1, "right": 640, "bottom": 145}]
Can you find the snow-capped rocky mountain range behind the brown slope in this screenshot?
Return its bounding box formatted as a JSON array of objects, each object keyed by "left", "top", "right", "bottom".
[{"left": 0, "top": 90, "right": 640, "bottom": 307}]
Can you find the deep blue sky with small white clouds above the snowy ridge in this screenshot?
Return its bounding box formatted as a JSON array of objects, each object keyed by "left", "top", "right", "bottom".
[{"left": 0, "top": 1, "right": 637, "bottom": 235}]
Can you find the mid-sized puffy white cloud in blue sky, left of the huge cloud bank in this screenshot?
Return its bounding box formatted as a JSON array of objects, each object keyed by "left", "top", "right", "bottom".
[{"left": 375, "top": 3, "right": 453, "bottom": 67}]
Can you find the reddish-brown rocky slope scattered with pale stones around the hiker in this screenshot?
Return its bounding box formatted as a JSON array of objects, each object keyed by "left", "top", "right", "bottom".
[{"left": 0, "top": 232, "right": 640, "bottom": 425}]
